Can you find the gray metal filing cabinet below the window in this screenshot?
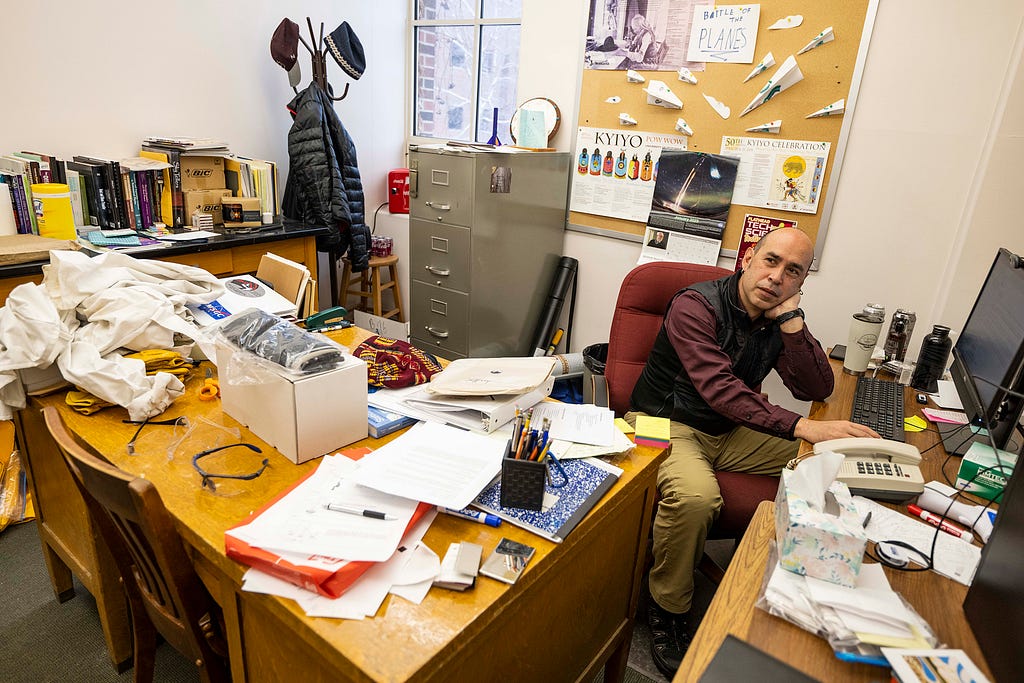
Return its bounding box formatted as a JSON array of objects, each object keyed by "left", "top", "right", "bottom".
[{"left": 409, "top": 145, "right": 569, "bottom": 358}]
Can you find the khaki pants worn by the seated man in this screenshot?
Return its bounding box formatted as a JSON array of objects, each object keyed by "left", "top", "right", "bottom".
[{"left": 626, "top": 413, "right": 798, "bottom": 613}]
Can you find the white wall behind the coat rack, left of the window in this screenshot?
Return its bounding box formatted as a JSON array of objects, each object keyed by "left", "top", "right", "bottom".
[{"left": 0, "top": 0, "right": 409, "bottom": 216}]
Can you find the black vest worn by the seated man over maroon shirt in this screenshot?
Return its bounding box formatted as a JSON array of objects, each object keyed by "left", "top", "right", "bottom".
[{"left": 630, "top": 272, "right": 782, "bottom": 435}]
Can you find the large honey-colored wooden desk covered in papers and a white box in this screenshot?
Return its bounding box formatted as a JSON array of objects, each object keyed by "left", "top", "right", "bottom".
[{"left": 18, "top": 330, "right": 666, "bottom": 681}]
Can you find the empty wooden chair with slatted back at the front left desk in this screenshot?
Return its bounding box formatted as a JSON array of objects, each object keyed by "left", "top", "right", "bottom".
[{"left": 43, "top": 407, "right": 230, "bottom": 681}]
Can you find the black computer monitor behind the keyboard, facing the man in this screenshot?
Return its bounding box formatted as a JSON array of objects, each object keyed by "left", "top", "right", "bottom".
[{"left": 945, "top": 249, "right": 1024, "bottom": 455}]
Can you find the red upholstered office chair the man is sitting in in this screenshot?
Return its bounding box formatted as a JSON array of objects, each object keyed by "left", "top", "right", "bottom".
[{"left": 604, "top": 261, "right": 778, "bottom": 583}]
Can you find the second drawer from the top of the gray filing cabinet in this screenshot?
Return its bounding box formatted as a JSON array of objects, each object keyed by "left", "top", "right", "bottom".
[{"left": 409, "top": 218, "right": 470, "bottom": 292}]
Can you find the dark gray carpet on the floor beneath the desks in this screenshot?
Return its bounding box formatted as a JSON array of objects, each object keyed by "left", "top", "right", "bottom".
[{"left": 0, "top": 522, "right": 731, "bottom": 683}]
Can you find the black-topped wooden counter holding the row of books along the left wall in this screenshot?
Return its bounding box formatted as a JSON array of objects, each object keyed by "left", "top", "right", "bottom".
[{"left": 0, "top": 223, "right": 328, "bottom": 306}]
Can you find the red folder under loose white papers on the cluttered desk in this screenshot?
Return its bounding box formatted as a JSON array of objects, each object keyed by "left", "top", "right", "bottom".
[{"left": 224, "top": 446, "right": 432, "bottom": 598}]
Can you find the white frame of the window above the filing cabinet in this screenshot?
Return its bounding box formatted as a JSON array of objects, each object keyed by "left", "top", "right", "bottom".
[{"left": 406, "top": 0, "right": 522, "bottom": 144}]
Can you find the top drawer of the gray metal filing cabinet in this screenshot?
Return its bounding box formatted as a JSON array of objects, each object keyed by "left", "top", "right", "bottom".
[{"left": 410, "top": 153, "right": 473, "bottom": 225}]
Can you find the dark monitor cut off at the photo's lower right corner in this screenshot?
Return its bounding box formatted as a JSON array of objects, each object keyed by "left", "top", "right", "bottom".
[{"left": 964, "top": 462, "right": 1024, "bottom": 681}]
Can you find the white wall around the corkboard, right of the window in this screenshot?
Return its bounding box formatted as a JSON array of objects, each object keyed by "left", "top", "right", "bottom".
[{"left": 519, "top": 0, "right": 1024, "bottom": 368}]
